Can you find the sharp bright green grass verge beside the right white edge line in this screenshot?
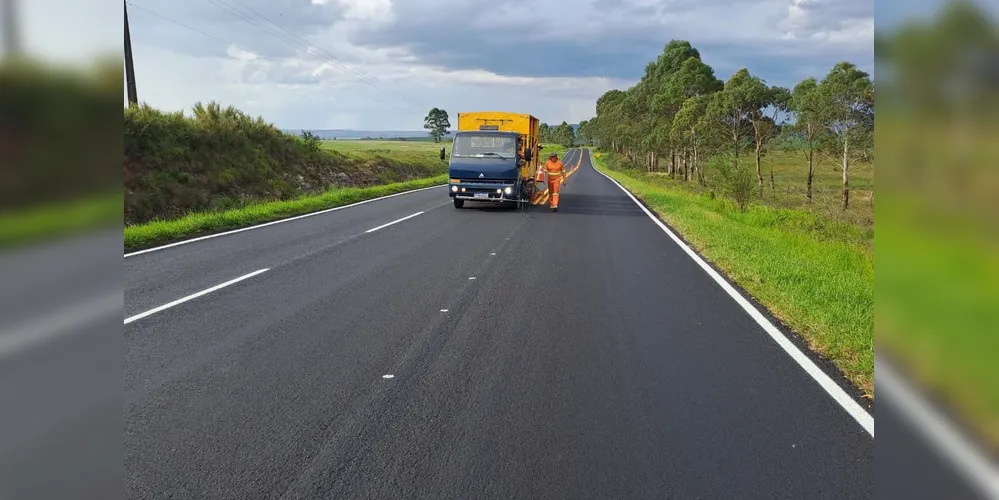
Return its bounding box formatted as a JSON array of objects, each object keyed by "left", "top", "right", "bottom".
[{"left": 594, "top": 152, "right": 874, "bottom": 397}]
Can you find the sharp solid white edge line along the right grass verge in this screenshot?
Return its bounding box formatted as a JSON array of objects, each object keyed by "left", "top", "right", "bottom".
[{"left": 591, "top": 150, "right": 874, "bottom": 437}]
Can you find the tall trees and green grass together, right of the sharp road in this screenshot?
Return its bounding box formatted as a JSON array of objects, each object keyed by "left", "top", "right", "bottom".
[{"left": 576, "top": 40, "right": 874, "bottom": 398}]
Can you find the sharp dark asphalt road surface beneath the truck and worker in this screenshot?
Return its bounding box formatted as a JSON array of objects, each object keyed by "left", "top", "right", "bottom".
[{"left": 124, "top": 150, "right": 976, "bottom": 499}]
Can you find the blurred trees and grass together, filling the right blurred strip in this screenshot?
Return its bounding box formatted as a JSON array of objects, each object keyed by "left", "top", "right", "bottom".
[{"left": 875, "top": 2, "right": 999, "bottom": 450}]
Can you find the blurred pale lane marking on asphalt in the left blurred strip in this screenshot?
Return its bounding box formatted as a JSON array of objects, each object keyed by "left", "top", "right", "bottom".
[{"left": 0, "top": 290, "right": 124, "bottom": 358}]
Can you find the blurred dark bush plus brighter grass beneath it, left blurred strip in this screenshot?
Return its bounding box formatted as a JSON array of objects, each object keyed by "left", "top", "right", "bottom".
[{"left": 0, "top": 58, "right": 121, "bottom": 247}]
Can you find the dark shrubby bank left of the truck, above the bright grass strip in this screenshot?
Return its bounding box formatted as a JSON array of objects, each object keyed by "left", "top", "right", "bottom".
[{"left": 124, "top": 102, "right": 446, "bottom": 225}]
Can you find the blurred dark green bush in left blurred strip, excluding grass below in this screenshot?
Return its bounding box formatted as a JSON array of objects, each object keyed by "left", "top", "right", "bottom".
[{"left": 0, "top": 61, "right": 122, "bottom": 211}]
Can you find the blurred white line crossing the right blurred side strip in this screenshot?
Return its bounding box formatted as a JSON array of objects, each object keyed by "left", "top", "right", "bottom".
[{"left": 874, "top": 356, "right": 999, "bottom": 498}]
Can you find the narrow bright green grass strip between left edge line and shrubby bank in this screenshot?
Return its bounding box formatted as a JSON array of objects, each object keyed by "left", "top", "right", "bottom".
[{"left": 127, "top": 175, "right": 447, "bottom": 252}]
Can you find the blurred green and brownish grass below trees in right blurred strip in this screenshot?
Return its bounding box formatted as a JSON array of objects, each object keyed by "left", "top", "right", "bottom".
[{"left": 875, "top": 115, "right": 999, "bottom": 453}]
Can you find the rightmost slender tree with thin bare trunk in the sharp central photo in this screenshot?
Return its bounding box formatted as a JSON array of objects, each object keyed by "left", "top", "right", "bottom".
[{"left": 818, "top": 62, "right": 874, "bottom": 210}]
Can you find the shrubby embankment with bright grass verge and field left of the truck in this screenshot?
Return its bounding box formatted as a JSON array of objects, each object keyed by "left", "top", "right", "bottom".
[{"left": 124, "top": 105, "right": 447, "bottom": 251}]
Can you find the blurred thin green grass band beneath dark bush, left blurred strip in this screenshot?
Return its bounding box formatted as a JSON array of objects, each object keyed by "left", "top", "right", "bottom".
[{"left": 0, "top": 190, "right": 122, "bottom": 248}]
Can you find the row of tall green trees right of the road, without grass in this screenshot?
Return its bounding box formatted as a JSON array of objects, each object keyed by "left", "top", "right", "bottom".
[{"left": 577, "top": 40, "right": 874, "bottom": 209}]
